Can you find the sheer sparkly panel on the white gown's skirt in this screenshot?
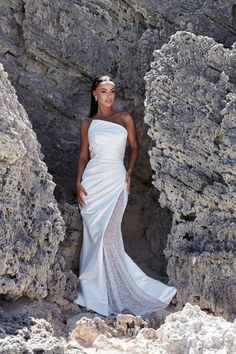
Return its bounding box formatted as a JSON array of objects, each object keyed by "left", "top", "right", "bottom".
[{"left": 103, "top": 191, "right": 166, "bottom": 315}]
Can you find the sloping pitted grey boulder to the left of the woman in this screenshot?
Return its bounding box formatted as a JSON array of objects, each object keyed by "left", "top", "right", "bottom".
[{"left": 0, "top": 65, "right": 75, "bottom": 300}]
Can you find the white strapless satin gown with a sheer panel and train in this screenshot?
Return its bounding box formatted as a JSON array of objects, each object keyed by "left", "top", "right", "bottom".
[{"left": 75, "top": 119, "right": 176, "bottom": 316}]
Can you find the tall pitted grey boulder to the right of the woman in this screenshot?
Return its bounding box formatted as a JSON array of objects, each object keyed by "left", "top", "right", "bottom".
[{"left": 145, "top": 32, "right": 236, "bottom": 317}]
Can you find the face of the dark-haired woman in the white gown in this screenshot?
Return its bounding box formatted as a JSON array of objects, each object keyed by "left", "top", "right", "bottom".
[{"left": 93, "top": 81, "right": 116, "bottom": 107}]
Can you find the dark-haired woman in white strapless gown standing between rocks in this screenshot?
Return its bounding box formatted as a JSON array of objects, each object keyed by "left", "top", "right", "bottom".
[{"left": 75, "top": 76, "right": 176, "bottom": 316}]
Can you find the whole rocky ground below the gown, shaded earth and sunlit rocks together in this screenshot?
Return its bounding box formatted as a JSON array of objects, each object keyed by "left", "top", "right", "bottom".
[{"left": 0, "top": 299, "right": 236, "bottom": 354}]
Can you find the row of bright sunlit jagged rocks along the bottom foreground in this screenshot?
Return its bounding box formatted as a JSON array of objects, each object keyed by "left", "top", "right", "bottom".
[{"left": 0, "top": 304, "right": 236, "bottom": 354}]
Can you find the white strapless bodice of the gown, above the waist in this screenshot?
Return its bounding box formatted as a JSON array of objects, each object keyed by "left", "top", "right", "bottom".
[{"left": 88, "top": 119, "right": 127, "bottom": 161}]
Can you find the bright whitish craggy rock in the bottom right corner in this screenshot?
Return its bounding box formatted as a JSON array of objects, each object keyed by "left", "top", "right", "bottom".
[{"left": 156, "top": 303, "right": 236, "bottom": 354}]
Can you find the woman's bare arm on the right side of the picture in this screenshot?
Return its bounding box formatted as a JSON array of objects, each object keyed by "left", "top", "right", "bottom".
[{"left": 125, "top": 113, "right": 139, "bottom": 191}]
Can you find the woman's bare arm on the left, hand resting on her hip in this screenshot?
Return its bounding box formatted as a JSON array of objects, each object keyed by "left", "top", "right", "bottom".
[{"left": 76, "top": 119, "right": 89, "bottom": 206}]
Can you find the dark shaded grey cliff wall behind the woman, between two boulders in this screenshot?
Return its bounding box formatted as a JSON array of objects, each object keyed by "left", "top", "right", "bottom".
[{"left": 0, "top": 0, "right": 236, "bottom": 282}]
